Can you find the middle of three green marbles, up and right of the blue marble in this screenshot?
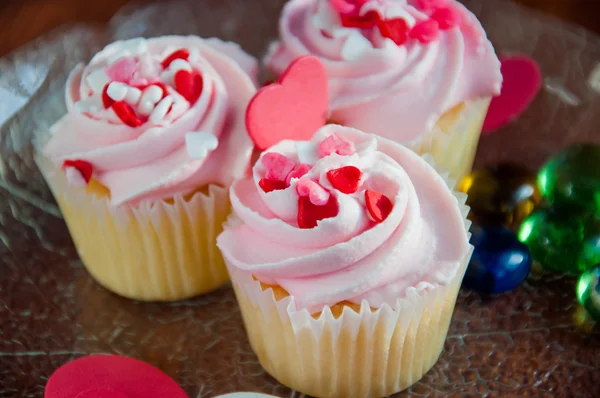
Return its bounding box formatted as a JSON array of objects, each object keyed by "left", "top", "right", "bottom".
[{"left": 518, "top": 209, "right": 600, "bottom": 275}]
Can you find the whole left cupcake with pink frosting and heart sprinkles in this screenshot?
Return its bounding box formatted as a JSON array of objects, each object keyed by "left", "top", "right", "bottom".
[{"left": 37, "top": 36, "right": 257, "bottom": 301}]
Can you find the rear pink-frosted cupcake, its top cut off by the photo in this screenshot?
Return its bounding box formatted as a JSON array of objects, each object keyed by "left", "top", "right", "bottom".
[{"left": 265, "top": 0, "right": 502, "bottom": 178}]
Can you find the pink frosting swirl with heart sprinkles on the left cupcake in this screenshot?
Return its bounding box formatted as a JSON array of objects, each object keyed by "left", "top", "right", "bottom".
[{"left": 44, "top": 36, "right": 257, "bottom": 205}]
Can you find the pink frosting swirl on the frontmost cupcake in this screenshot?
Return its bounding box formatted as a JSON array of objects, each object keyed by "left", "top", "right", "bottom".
[{"left": 217, "top": 125, "right": 469, "bottom": 313}]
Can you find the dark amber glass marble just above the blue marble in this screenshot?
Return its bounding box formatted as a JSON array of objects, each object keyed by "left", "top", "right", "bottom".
[{"left": 458, "top": 163, "right": 542, "bottom": 229}]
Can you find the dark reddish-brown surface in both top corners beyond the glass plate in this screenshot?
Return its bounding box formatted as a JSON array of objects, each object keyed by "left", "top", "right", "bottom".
[{"left": 0, "top": 0, "right": 600, "bottom": 56}]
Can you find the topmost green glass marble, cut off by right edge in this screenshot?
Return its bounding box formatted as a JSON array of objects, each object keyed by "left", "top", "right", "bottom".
[{"left": 538, "top": 144, "right": 600, "bottom": 214}]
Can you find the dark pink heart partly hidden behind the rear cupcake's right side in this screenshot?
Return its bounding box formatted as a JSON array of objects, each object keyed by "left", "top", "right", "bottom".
[{"left": 482, "top": 55, "right": 542, "bottom": 134}]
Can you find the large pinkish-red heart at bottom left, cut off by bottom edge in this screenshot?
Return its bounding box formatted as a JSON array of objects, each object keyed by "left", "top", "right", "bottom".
[{"left": 44, "top": 355, "right": 187, "bottom": 398}]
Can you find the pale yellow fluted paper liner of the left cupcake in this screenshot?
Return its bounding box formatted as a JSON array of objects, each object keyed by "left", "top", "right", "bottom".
[{"left": 36, "top": 157, "right": 230, "bottom": 301}]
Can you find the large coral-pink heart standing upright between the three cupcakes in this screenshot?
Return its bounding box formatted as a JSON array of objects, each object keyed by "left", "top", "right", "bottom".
[{"left": 246, "top": 55, "right": 328, "bottom": 150}]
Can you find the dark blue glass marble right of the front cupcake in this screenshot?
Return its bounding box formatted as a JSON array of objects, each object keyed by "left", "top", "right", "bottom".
[{"left": 463, "top": 226, "right": 532, "bottom": 293}]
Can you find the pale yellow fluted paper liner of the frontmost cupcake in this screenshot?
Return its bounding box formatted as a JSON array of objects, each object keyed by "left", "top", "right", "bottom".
[{"left": 225, "top": 159, "right": 473, "bottom": 398}]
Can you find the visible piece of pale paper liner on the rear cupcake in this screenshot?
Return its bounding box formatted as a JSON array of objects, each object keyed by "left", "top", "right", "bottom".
[{"left": 405, "top": 98, "right": 491, "bottom": 181}]
